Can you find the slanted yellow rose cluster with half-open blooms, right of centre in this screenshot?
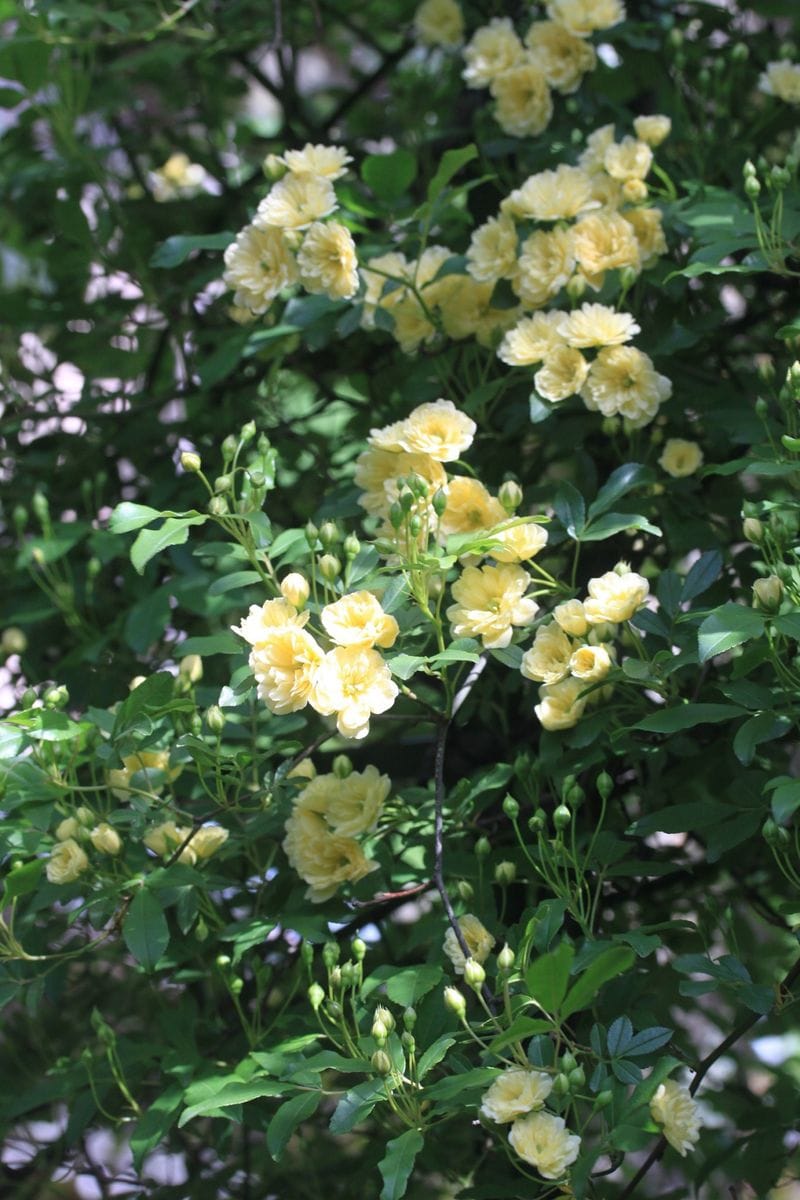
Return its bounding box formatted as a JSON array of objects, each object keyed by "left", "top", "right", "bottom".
[{"left": 519, "top": 563, "right": 650, "bottom": 730}]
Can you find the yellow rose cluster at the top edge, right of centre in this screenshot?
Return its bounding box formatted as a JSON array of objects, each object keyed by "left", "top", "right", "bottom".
[{"left": 463, "top": 0, "right": 625, "bottom": 138}]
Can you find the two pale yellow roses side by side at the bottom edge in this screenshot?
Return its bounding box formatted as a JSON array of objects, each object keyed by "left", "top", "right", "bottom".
[{"left": 481, "top": 1067, "right": 581, "bottom": 1180}]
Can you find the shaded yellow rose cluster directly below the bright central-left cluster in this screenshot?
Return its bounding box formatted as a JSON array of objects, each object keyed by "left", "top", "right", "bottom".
[{"left": 283, "top": 766, "right": 391, "bottom": 904}]
